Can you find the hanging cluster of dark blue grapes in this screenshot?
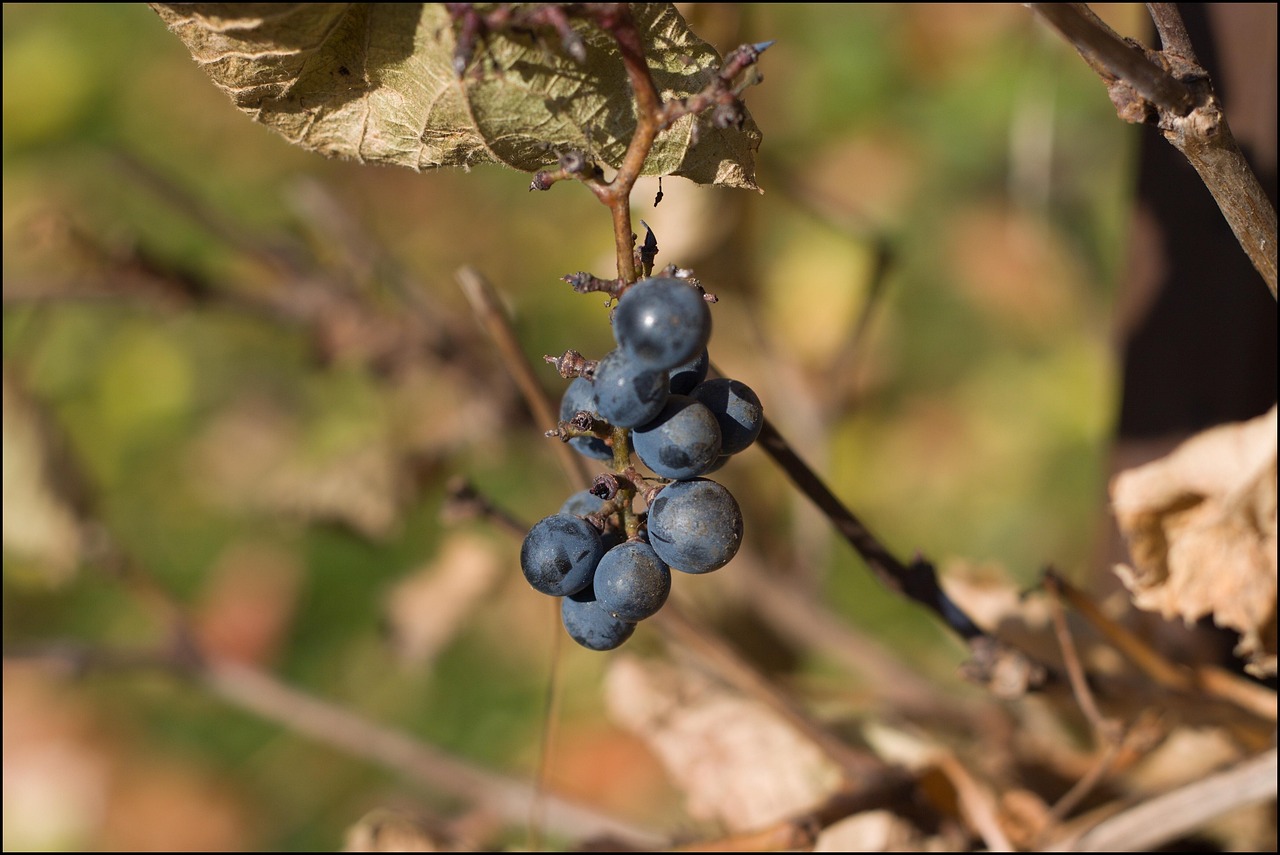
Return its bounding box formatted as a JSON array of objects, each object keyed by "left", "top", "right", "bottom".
[{"left": 520, "top": 276, "right": 764, "bottom": 650}]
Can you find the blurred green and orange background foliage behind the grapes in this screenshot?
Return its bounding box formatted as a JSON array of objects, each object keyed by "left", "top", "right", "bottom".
[{"left": 3, "top": 4, "right": 1142, "bottom": 850}]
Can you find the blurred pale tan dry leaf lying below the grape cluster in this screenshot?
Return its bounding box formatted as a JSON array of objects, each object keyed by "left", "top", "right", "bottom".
[{"left": 605, "top": 655, "right": 841, "bottom": 832}]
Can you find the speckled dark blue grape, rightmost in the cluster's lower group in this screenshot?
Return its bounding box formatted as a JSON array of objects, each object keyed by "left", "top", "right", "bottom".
[{"left": 649, "top": 477, "right": 742, "bottom": 573}]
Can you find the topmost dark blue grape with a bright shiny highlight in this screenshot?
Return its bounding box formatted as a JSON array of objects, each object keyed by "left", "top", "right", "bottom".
[{"left": 613, "top": 278, "right": 712, "bottom": 371}]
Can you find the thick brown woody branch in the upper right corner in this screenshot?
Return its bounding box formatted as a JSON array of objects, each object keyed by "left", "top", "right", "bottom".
[{"left": 1029, "top": 3, "right": 1276, "bottom": 297}]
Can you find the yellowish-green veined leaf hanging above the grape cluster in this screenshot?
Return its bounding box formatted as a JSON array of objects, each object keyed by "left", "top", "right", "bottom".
[{"left": 151, "top": 3, "right": 760, "bottom": 189}]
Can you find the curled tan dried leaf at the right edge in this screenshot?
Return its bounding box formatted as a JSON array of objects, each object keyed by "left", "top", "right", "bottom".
[{"left": 1111, "top": 407, "right": 1276, "bottom": 675}]
